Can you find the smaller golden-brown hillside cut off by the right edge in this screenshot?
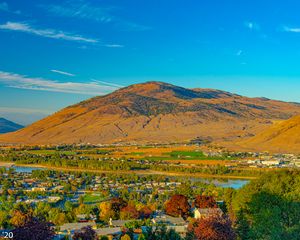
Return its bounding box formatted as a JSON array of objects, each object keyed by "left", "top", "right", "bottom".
[{"left": 239, "top": 115, "right": 300, "bottom": 153}]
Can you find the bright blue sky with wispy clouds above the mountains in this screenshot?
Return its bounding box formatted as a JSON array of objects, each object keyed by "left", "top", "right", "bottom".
[{"left": 0, "top": 0, "right": 300, "bottom": 124}]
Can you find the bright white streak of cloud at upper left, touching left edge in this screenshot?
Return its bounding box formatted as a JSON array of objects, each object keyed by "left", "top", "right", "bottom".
[{"left": 0, "top": 22, "right": 98, "bottom": 43}]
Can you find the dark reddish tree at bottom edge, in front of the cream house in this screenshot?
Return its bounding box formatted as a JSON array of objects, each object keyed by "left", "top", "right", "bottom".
[{"left": 188, "top": 215, "right": 236, "bottom": 240}]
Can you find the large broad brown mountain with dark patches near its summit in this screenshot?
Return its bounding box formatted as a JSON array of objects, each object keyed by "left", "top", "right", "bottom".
[{"left": 0, "top": 82, "right": 300, "bottom": 144}]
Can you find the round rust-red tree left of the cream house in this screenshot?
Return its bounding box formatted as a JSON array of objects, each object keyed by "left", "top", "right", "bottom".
[{"left": 165, "top": 194, "right": 191, "bottom": 218}]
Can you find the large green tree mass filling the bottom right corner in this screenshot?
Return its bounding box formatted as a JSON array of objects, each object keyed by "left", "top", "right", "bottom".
[{"left": 232, "top": 170, "right": 300, "bottom": 240}]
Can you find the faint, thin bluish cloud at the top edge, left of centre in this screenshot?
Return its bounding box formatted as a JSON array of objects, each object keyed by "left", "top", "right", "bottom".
[{"left": 41, "top": 0, "right": 150, "bottom": 31}]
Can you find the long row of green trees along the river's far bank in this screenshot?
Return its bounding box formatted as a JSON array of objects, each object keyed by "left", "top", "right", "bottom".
[{"left": 0, "top": 152, "right": 263, "bottom": 176}]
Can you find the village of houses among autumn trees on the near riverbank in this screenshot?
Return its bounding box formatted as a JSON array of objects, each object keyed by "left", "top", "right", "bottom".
[{"left": 0, "top": 168, "right": 229, "bottom": 239}]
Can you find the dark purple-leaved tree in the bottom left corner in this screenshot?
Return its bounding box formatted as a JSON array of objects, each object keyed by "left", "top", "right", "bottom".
[{"left": 12, "top": 218, "right": 54, "bottom": 240}]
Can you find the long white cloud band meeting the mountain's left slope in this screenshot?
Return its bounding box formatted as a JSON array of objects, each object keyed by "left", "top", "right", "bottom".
[{"left": 0, "top": 71, "right": 121, "bottom": 95}]
